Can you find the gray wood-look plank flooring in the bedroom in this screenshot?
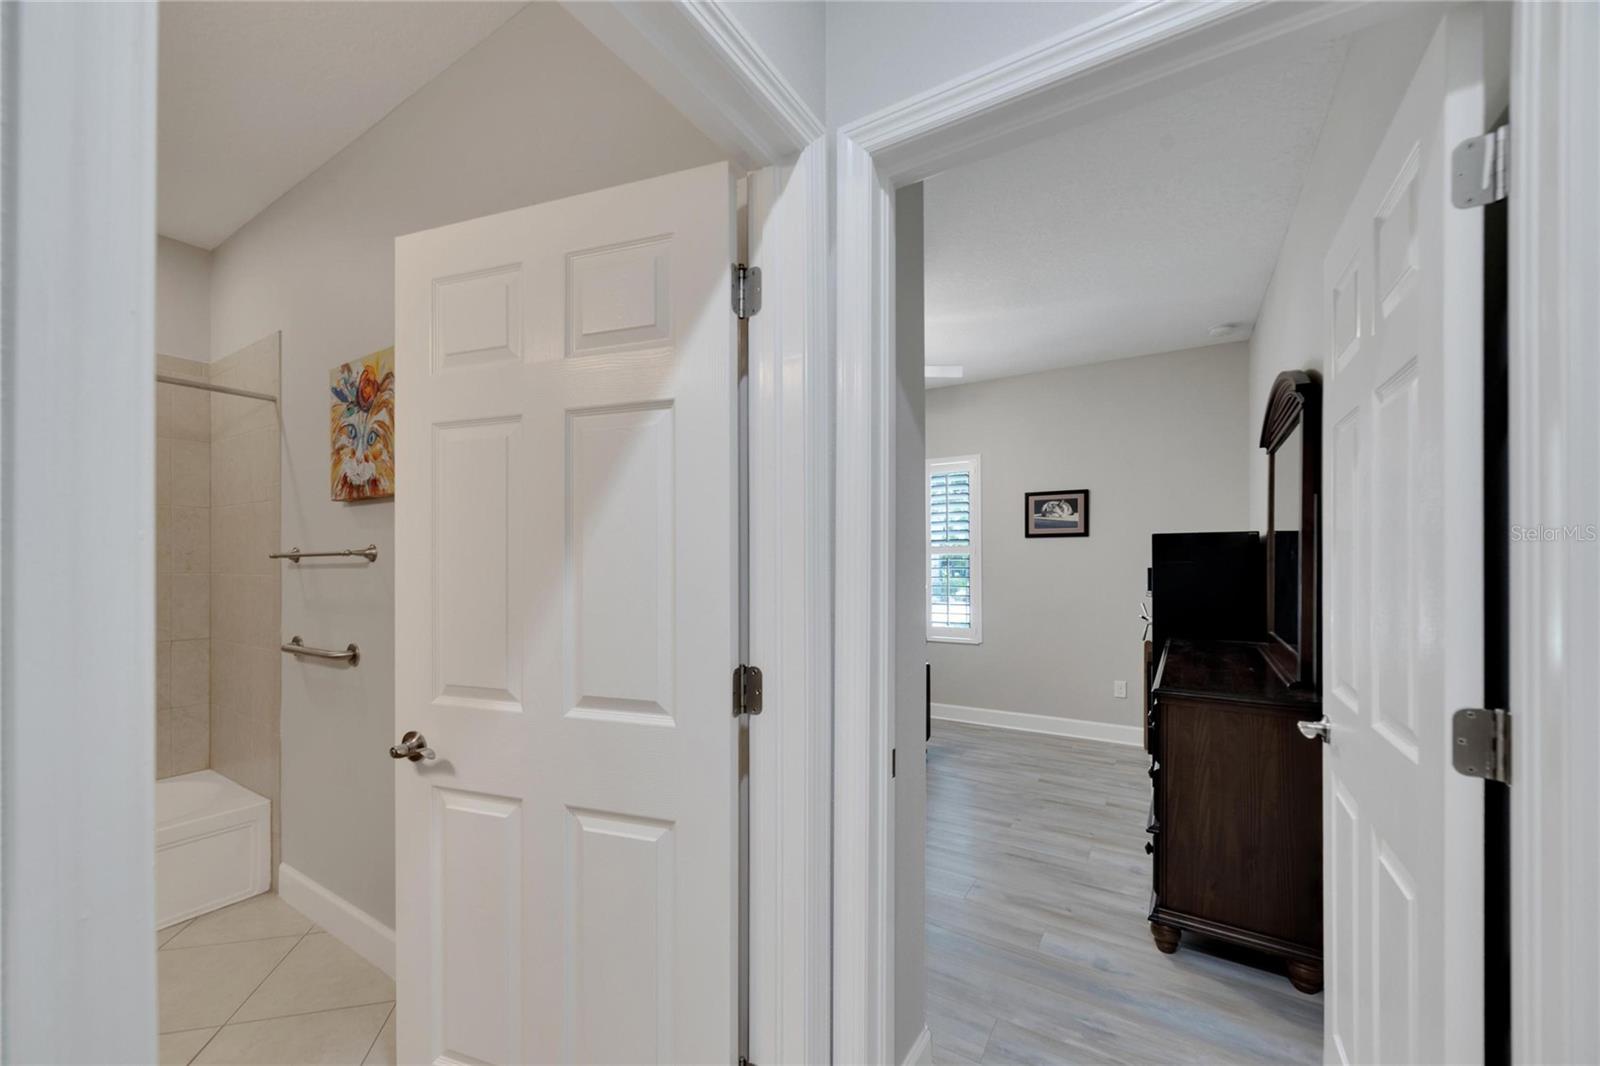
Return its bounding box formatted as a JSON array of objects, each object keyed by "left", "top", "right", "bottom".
[{"left": 926, "top": 722, "right": 1323, "bottom": 1063}]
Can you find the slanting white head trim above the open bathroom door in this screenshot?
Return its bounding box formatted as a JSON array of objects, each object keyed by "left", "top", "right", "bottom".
[{"left": 562, "top": 0, "right": 824, "bottom": 170}]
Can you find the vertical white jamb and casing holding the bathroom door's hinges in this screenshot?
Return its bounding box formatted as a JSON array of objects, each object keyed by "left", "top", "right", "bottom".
[{"left": 747, "top": 141, "right": 834, "bottom": 1063}]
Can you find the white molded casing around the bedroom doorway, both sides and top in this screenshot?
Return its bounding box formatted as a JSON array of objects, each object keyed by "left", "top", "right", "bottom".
[{"left": 834, "top": 3, "right": 1600, "bottom": 1063}]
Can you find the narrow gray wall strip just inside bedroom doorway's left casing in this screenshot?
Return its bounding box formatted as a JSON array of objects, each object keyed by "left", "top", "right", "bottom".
[{"left": 894, "top": 184, "right": 928, "bottom": 1061}]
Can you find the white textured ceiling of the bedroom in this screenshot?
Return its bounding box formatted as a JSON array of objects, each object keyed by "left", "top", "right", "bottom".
[{"left": 923, "top": 40, "right": 1346, "bottom": 384}]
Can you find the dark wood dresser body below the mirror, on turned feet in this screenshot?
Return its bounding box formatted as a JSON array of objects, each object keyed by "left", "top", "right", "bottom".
[{"left": 1149, "top": 639, "right": 1322, "bottom": 992}]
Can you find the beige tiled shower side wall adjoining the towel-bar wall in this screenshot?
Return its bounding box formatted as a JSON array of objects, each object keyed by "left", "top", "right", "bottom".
[{"left": 210, "top": 333, "right": 286, "bottom": 879}]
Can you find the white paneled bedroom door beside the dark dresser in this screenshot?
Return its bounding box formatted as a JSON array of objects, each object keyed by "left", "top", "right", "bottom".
[{"left": 1323, "top": 8, "right": 1488, "bottom": 1063}]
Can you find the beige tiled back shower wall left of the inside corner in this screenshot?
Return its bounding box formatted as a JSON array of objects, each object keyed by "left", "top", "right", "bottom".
[{"left": 155, "top": 355, "right": 211, "bottom": 778}]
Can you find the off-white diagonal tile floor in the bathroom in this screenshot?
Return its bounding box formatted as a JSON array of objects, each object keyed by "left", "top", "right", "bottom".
[{"left": 155, "top": 893, "right": 395, "bottom": 1066}]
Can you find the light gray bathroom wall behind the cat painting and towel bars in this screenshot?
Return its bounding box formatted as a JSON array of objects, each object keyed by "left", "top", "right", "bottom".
[{"left": 211, "top": 3, "right": 722, "bottom": 925}]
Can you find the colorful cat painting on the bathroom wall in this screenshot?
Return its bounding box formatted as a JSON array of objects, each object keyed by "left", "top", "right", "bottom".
[{"left": 328, "top": 347, "right": 395, "bottom": 501}]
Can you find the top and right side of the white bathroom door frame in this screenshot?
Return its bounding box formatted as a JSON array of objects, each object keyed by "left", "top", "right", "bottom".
[{"left": 565, "top": 8, "right": 835, "bottom": 1063}]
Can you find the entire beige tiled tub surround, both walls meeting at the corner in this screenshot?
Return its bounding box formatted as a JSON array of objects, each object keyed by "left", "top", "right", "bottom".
[{"left": 155, "top": 333, "right": 282, "bottom": 877}]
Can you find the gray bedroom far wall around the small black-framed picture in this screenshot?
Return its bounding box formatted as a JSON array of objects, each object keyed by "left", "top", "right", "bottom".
[{"left": 926, "top": 344, "right": 1251, "bottom": 727}]
